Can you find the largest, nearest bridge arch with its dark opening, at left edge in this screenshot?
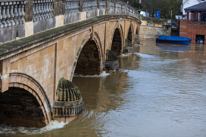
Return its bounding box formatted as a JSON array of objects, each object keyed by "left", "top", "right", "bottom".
[{"left": 0, "top": 73, "right": 52, "bottom": 127}]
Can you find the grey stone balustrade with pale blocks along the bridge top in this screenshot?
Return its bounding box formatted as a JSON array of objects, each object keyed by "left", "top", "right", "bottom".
[{"left": 0, "top": 0, "right": 139, "bottom": 43}]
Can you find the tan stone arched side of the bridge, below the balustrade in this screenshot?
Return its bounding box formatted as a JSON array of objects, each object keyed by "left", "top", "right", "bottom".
[{"left": 0, "top": 12, "right": 141, "bottom": 127}]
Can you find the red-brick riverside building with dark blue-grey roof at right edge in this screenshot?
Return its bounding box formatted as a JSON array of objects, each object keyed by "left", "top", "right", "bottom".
[{"left": 179, "top": 2, "right": 206, "bottom": 44}]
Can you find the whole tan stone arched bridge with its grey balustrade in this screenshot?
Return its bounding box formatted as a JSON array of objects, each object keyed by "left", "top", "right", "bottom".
[{"left": 0, "top": 0, "right": 141, "bottom": 127}]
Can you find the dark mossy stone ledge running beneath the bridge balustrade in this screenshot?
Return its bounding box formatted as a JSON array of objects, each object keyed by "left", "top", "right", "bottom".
[{"left": 0, "top": 15, "right": 141, "bottom": 60}]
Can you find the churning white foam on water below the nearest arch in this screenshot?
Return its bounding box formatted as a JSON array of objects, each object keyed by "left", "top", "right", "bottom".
[{"left": 0, "top": 120, "right": 68, "bottom": 135}]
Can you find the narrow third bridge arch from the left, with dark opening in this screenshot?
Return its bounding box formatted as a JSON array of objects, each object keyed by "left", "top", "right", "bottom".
[{"left": 111, "top": 24, "right": 124, "bottom": 55}]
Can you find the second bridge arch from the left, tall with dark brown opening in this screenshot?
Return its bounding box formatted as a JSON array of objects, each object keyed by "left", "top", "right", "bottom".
[{"left": 71, "top": 32, "right": 103, "bottom": 76}]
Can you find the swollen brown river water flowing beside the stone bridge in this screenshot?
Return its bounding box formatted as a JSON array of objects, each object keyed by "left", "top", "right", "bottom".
[{"left": 0, "top": 41, "right": 206, "bottom": 137}]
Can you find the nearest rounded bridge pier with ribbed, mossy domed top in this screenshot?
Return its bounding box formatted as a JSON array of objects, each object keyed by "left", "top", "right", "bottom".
[{"left": 53, "top": 78, "right": 84, "bottom": 122}]
